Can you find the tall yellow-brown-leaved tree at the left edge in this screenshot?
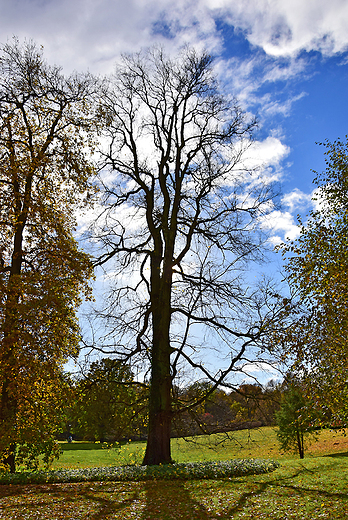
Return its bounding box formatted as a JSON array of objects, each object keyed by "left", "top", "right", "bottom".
[{"left": 0, "top": 39, "right": 95, "bottom": 472}]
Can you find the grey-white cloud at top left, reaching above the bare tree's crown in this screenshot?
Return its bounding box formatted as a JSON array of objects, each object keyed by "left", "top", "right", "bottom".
[{"left": 0, "top": 0, "right": 220, "bottom": 74}]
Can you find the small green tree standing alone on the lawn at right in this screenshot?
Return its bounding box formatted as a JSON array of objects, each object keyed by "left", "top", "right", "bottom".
[{"left": 275, "top": 385, "right": 318, "bottom": 459}]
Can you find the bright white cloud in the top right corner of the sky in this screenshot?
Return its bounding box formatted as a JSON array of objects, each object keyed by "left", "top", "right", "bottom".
[{"left": 211, "top": 0, "right": 348, "bottom": 56}]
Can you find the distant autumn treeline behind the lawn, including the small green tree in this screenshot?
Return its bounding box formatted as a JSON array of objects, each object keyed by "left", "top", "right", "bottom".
[{"left": 57, "top": 364, "right": 339, "bottom": 459}]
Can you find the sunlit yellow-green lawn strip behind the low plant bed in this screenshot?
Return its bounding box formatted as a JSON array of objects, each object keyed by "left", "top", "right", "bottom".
[{"left": 48, "top": 427, "right": 348, "bottom": 469}]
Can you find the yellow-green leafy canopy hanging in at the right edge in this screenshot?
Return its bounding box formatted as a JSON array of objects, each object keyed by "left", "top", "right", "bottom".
[{"left": 281, "top": 140, "right": 348, "bottom": 425}]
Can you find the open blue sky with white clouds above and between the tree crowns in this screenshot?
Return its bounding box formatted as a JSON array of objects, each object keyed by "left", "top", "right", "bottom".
[{"left": 0, "top": 0, "right": 348, "bottom": 242}]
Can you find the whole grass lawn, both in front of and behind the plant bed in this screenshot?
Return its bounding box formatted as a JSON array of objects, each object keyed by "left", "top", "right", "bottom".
[{"left": 0, "top": 428, "right": 348, "bottom": 520}]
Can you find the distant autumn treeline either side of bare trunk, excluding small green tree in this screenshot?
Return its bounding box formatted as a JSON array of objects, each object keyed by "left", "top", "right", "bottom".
[{"left": 59, "top": 358, "right": 282, "bottom": 442}]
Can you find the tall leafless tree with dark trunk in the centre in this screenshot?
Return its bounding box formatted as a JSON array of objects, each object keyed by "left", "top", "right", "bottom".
[{"left": 95, "top": 49, "right": 282, "bottom": 464}]
